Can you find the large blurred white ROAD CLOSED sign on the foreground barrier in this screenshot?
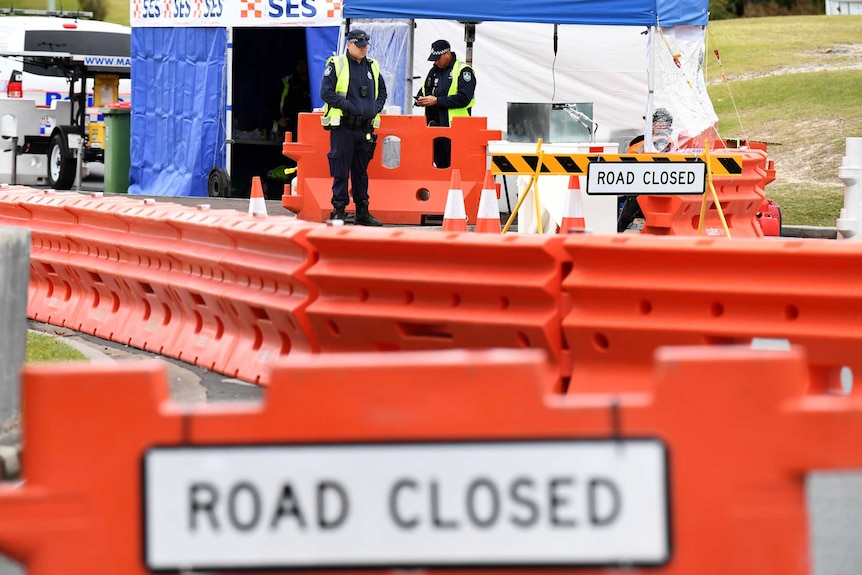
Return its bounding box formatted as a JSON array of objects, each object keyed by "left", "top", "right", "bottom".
[{"left": 142, "top": 439, "right": 670, "bottom": 571}]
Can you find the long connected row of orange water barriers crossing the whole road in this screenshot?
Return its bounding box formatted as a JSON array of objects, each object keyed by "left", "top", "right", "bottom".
[{"left": 11, "top": 184, "right": 862, "bottom": 400}]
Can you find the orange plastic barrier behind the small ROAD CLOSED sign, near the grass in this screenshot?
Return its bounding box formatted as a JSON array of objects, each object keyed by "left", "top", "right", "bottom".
[{"left": 638, "top": 149, "right": 775, "bottom": 238}]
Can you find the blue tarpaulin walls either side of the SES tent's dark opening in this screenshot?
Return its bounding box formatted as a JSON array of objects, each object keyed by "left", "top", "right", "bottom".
[{"left": 129, "top": 26, "right": 338, "bottom": 196}]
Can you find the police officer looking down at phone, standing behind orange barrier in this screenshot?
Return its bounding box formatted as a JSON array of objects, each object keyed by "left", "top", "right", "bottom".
[{"left": 415, "top": 40, "right": 476, "bottom": 168}]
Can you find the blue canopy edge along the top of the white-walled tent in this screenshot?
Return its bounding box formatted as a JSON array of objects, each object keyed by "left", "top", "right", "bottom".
[{"left": 343, "top": 0, "right": 709, "bottom": 26}]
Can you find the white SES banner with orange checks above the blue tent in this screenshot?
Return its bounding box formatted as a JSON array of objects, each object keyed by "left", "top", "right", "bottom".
[{"left": 130, "top": 0, "right": 343, "bottom": 27}]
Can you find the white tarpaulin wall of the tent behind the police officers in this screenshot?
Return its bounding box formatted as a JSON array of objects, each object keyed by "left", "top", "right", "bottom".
[{"left": 413, "top": 20, "right": 648, "bottom": 146}]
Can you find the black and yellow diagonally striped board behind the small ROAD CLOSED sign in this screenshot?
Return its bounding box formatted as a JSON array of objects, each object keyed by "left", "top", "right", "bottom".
[{"left": 491, "top": 153, "right": 742, "bottom": 176}]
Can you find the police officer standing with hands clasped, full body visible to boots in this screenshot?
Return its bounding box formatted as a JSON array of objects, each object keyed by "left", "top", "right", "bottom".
[{"left": 320, "top": 30, "right": 386, "bottom": 226}]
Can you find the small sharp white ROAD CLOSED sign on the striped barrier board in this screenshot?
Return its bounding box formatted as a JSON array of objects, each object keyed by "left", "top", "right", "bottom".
[{"left": 586, "top": 162, "right": 706, "bottom": 196}]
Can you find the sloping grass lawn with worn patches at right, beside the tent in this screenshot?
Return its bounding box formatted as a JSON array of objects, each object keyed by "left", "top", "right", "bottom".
[{"left": 706, "top": 16, "right": 862, "bottom": 227}]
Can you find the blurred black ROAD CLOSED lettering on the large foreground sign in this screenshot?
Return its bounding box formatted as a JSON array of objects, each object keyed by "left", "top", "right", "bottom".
[{"left": 188, "top": 476, "right": 623, "bottom": 534}]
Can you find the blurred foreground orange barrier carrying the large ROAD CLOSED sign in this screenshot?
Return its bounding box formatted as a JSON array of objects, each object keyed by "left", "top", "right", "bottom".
[{"left": 5, "top": 347, "right": 862, "bottom": 575}]
